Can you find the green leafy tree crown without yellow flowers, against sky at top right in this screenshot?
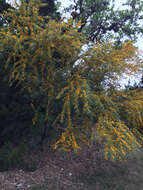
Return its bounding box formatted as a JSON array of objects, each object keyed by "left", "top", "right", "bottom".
[{"left": 66, "top": 0, "right": 143, "bottom": 44}]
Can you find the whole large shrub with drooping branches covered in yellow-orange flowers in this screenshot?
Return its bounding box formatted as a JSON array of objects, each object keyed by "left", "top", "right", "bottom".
[{"left": 0, "top": 1, "right": 143, "bottom": 159}]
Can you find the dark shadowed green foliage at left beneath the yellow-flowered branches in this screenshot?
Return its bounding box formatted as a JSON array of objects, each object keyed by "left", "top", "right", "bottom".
[{"left": 0, "top": 52, "right": 48, "bottom": 146}]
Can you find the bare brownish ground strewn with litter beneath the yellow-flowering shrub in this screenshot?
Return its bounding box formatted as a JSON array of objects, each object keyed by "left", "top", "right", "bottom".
[{"left": 0, "top": 144, "right": 143, "bottom": 190}]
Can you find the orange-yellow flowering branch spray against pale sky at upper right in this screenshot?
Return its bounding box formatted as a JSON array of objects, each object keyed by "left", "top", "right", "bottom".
[{"left": 79, "top": 41, "right": 142, "bottom": 90}]
